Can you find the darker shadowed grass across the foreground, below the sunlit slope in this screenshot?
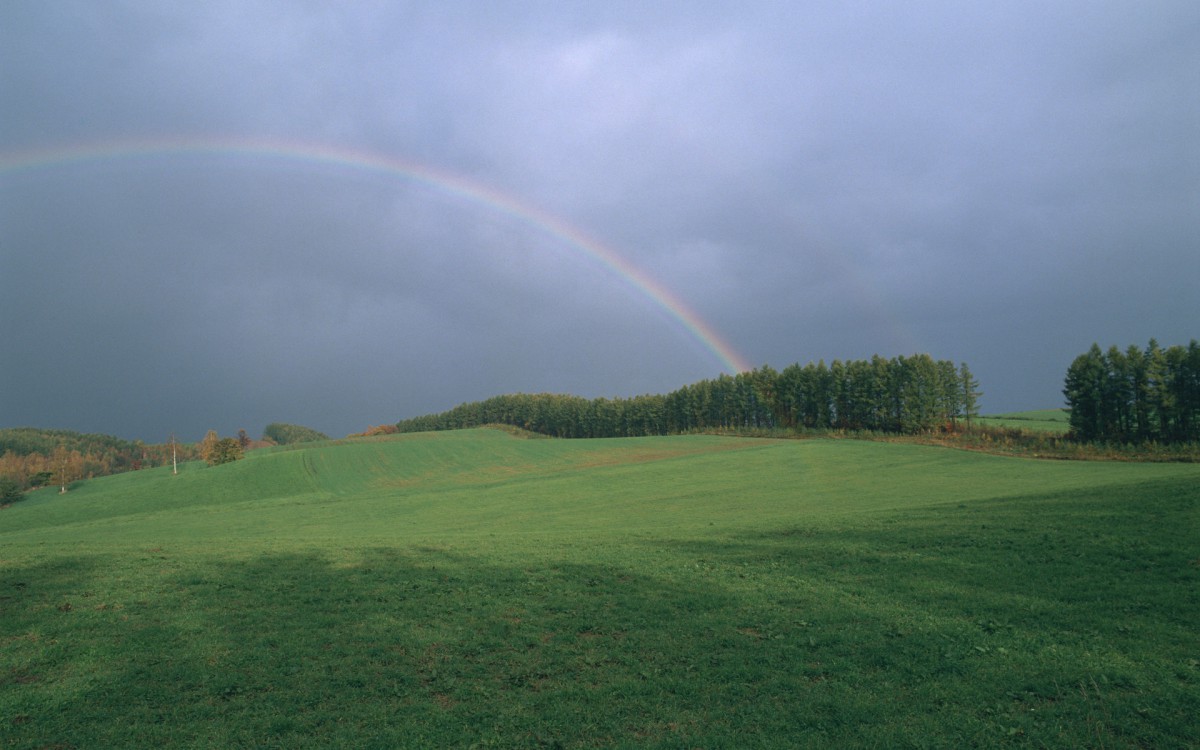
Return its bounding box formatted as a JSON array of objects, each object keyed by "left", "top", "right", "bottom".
[{"left": 0, "top": 484, "right": 1200, "bottom": 748}]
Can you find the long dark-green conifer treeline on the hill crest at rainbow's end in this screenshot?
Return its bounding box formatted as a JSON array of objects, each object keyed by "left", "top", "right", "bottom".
[{"left": 393, "top": 354, "right": 980, "bottom": 438}]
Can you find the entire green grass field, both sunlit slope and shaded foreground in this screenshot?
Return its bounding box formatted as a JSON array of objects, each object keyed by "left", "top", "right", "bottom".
[{"left": 0, "top": 430, "right": 1200, "bottom": 749}]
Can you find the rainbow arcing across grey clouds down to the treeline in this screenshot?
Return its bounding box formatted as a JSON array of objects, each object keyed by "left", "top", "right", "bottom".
[{"left": 0, "top": 138, "right": 751, "bottom": 373}]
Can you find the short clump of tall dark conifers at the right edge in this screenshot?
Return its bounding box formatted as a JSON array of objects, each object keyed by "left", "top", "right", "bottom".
[{"left": 1063, "top": 338, "right": 1200, "bottom": 443}]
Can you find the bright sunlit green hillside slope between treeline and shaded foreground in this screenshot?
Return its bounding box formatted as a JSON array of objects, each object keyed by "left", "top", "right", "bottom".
[{"left": 7, "top": 430, "right": 1200, "bottom": 545}]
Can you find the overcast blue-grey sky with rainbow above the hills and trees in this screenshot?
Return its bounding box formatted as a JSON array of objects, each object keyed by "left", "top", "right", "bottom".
[{"left": 0, "top": 0, "right": 1200, "bottom": 443}]
